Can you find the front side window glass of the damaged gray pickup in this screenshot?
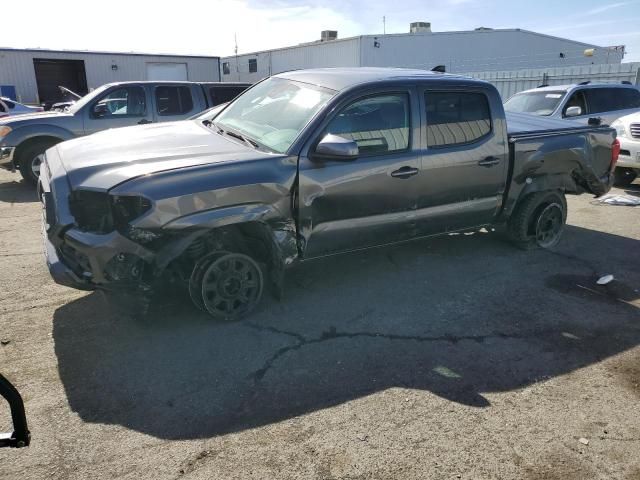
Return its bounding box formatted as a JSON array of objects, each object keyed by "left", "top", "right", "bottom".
[{"left": 327, "top": 93, "right": 409, "bottom": 155}]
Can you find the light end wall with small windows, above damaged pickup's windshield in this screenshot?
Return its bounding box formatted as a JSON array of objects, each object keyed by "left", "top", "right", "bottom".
[{"left": 221, "top": 37, "right": 360, "bottom": 82}]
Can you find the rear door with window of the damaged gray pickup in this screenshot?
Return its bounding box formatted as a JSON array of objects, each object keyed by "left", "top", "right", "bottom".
[{"left": 416, "top": 87, "right": 508, "bottom": 235}]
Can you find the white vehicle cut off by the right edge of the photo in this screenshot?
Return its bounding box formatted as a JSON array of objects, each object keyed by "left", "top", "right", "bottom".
[{"left": 611, "top": 113, "right": 640, "bottom": 187}]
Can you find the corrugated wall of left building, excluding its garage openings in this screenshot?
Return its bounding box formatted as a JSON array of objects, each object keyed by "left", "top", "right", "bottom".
[{"left": 0, "top": 49, "right": 220, "bottom": 103}]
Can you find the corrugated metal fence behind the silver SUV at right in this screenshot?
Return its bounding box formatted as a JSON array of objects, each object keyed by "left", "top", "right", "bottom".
[{"left": 465, "top": 62, "right": 640, "bottom": 100}]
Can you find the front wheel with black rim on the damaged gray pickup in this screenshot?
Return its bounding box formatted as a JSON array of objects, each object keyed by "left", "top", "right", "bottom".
[{"left": 189, "top": 252, "right": 264, "bottom": 321}]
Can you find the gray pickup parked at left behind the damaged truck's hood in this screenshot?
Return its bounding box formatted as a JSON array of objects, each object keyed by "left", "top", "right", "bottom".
[{"left": 0, "top": 82, "right": 250, "bottom": 185}]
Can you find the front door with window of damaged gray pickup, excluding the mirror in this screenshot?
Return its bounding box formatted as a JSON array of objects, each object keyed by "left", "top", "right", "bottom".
[{"left": 298, "top": 88, "right": 420, "bottom": 258}]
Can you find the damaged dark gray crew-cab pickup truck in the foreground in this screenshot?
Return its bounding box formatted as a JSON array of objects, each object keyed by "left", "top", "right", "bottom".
[{"left": 39, "top": 68, "right": 617, "bottom": 320}]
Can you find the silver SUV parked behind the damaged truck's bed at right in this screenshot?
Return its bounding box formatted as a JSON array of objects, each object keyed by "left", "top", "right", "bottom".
[{"left": 504, "top": 82, "right": 640, "bottom": 125}]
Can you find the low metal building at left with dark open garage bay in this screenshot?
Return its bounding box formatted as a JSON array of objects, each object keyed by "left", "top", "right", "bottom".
[{"left": 0, "top": 48, "right": 220, "bottom": 104}]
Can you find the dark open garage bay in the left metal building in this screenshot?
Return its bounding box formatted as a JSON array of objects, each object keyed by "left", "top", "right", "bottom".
[{"left": 33, "top": 58, "right": 87, "bottom": 110}]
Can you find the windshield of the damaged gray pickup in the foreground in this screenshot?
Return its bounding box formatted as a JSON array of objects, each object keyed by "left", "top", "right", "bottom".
[{"left": 214, "top": 77, "right": 335, "bottom": 153}]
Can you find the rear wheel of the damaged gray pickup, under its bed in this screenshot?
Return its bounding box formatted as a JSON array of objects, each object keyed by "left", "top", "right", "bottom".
[{"left": 507, "top": 192, "right": 567, "bottom": 250}]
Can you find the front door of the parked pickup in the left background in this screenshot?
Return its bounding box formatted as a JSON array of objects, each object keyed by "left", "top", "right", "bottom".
[{"left": 83, "top": 85, "right": 153, "bottom": 135}]
